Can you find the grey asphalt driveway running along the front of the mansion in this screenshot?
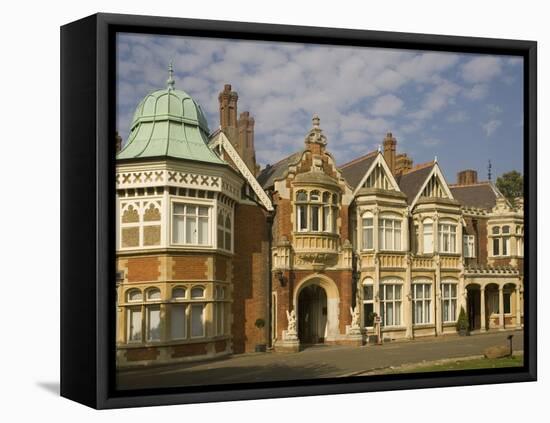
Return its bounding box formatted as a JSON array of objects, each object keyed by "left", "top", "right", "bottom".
[{"left": 117, "top": 331, "right": 523, "bottom": 389}]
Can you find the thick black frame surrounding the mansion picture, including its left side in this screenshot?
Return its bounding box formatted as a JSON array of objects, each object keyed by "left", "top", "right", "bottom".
[{"left": 61, "top": 14, "right": 537, "bottom": 409}]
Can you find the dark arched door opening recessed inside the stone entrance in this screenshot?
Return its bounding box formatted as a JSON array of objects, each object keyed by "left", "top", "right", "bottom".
[{"left": 298, "top": 284, "right": 327, "bottom": 344}]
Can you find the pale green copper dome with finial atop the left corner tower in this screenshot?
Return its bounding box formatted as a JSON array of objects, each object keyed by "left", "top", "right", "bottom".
[{"left": 117, "top": 65, "right": 225, "bottom": 163}]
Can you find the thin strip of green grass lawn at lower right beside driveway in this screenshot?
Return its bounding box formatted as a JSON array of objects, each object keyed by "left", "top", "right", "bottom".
[{"left": 382, "top": 354, "right": 523, "bottom": 374}]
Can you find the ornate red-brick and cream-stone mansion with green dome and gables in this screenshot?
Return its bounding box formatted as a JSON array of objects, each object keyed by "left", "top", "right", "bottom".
[{"left": 116, "top": 70, "right": 524, "bottom": 367}]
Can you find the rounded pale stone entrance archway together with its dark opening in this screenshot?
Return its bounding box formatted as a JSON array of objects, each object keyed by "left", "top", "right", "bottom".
[{"left": 293, "top": 275, "right": 340, "bottom": 344}]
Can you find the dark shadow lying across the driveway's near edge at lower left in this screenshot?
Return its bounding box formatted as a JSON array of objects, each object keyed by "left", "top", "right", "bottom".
[{"left": 117, "top": 364, "right": 341, "bottom": 390}]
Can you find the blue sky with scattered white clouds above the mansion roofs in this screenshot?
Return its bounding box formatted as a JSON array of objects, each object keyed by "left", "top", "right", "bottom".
[{"left": 117, "top": 34, "right": 523, "bottom": 183}]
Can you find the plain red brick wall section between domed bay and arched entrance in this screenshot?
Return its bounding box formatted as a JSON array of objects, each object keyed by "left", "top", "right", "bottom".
[{"left": 232, "top": 204, "right": 270, "bottom": 353}]
